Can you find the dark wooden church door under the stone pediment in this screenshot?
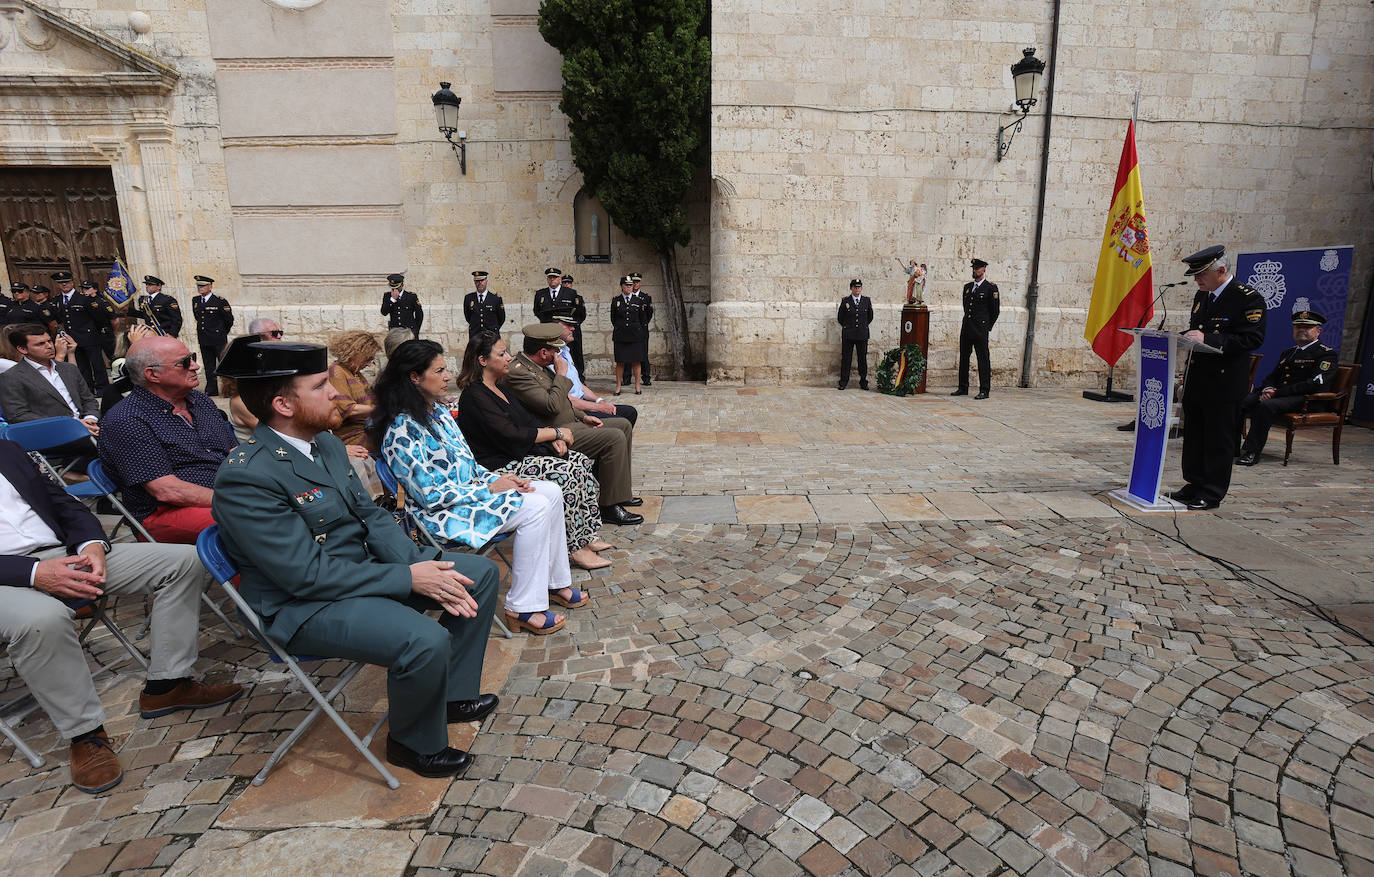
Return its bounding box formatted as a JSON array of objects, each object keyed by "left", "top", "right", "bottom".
[{"left": 0, "top": 168, "right": 128, "bottom": 289}]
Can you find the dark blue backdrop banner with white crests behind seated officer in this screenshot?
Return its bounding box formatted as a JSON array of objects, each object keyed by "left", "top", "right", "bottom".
[{"left": 1235, "top": 246, "right": 1355, "bottom": 382}]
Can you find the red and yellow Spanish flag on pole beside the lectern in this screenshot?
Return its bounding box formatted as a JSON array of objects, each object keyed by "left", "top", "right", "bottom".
[{"left": 1083, "top": 122, "right": 1154, "bottom": 366}]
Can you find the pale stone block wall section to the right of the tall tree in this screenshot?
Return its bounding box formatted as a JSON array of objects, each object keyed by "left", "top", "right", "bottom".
[{"left": 708, "top": 0, "right": 1374, "bottom": 385}]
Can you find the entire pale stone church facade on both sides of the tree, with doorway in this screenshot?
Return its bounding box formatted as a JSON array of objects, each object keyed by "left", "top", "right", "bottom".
[{"left": 0, "top": 0, "right": 1374, "bottom": 386}]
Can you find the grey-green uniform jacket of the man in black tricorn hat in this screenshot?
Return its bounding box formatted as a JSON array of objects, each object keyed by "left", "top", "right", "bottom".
[{"left": 212, "top": 425, "right": 440, "bottom": 642}]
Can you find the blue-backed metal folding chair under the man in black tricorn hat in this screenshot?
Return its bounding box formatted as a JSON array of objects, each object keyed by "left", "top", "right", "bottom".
[{"left": 195, "top": 525, "right": 401, "bottom": 789}]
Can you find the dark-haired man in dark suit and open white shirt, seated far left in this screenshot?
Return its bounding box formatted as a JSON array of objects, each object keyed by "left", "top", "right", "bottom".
[{"left": 0, "top": 323, "right": 100, "bottom": 436}]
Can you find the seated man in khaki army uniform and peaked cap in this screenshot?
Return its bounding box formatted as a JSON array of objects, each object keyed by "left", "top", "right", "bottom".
[{"left": 502, "top": 323, "right": 644, "bottom": 524}]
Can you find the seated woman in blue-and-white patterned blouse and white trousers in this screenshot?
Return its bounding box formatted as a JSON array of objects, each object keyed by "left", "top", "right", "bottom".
[{"left": 371, "top": 341, "right": 591, "bottom": 634}]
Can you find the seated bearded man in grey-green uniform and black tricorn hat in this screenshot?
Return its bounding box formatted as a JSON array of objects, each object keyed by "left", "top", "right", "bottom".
[{"left": 212, "top": 341, "right": 500, "bottom": 777}]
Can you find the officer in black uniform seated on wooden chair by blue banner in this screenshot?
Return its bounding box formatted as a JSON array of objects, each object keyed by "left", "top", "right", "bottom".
[{"left": 1237, "top": 311, "right": 1337, "bottom": 466}]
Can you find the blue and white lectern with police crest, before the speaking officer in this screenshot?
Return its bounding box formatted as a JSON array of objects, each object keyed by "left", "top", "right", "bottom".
[{"left": 1109, "top": 329, "right": 1221, "bottom": 511}]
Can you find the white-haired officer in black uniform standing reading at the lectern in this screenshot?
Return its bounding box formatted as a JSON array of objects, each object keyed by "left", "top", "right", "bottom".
[{"left": 1171, "top": 246, "right": 1264, "bottom": 511}]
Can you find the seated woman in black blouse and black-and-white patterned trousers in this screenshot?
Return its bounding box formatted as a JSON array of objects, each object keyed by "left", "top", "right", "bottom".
[{"left": 458, "top": 330, "right": 611, "bottom": 569}]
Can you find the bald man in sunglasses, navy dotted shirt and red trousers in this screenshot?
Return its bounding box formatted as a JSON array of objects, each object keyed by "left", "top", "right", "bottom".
[{"left": 100, "top": 335, "right": 238, "bottom": 543}]
